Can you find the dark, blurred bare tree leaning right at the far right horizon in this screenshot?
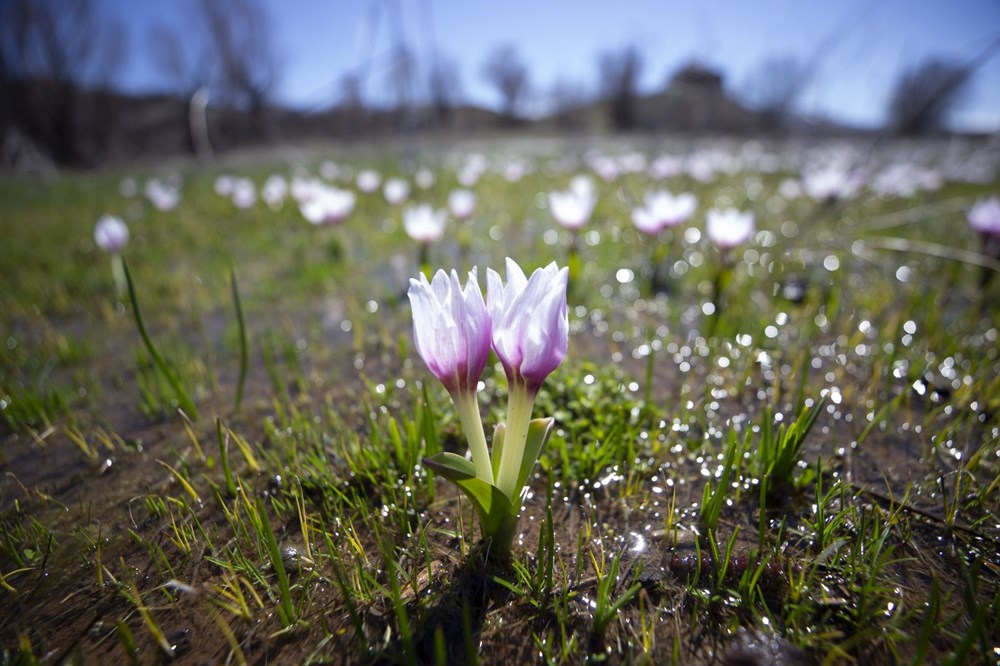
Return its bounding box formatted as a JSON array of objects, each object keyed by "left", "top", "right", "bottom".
[{"left": 889, "top": 58, "right": 973, "bottom": 135}]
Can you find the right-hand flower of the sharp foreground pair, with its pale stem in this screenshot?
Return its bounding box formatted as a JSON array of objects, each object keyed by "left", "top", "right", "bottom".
[{"left": 486, "top": 258, "right": 569, "bottom": 502}]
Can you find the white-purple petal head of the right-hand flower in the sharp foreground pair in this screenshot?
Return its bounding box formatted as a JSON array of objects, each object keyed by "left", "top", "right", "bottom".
[{"left": 486, "top": 258, "right": 569, "bottom": 394}]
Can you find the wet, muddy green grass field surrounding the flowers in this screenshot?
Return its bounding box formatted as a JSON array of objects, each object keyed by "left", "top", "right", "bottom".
[{"left": 0, "top": 137, "right": 1000, "bottom": 664}]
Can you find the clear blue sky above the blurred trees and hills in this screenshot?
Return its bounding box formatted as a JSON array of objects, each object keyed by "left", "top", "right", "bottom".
[{"left": 102, "top": 0, "right": 1000, "bottom": 131}]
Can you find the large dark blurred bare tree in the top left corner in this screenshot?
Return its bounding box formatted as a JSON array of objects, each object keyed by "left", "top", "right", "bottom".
[{"left": 0, "top": 0, "right": 127, "bottom": 163}]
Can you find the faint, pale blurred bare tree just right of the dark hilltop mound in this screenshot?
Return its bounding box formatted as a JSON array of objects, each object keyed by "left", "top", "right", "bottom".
[{"left": 743, "top": 55, "right": 813, "bottom": 131}]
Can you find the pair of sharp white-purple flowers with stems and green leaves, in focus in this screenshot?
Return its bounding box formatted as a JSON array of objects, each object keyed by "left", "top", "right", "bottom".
[{"left": 408, "top": 258, "right": 569, "bottom": 554}]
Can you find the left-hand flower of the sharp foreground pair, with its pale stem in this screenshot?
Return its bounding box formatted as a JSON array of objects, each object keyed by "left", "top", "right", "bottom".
[{"left": 407, "top": 270, "right": 493, "bottom": 483}]
